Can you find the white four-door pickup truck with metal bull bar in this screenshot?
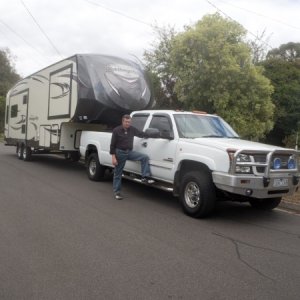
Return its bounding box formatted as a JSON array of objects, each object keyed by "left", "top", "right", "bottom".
[{"left": 80, "top": 110, "right": 299, "bottom": 217}]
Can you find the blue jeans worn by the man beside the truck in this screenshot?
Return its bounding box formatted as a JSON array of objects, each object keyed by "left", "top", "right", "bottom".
[{"left": 113, "top": 149, "right": 151, "bottom": 193}]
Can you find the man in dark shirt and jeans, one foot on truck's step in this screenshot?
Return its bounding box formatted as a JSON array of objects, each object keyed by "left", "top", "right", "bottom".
[{"left": 110, "top": 115, "right": 154, "bottom": 200}]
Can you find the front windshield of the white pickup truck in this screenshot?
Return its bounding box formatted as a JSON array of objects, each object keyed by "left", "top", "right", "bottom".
[{"left": 174, "top": 114, "right": 239, "bottom": 138}]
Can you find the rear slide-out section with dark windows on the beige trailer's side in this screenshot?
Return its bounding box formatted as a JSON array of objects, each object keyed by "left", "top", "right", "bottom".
[{"left": 8, "top": 89, "right": 29, "bottom": 140}]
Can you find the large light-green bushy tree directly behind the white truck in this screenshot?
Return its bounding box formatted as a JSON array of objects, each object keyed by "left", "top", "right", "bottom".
[{"left": 145, "top": 14, "right": 274, "bottom": 139}]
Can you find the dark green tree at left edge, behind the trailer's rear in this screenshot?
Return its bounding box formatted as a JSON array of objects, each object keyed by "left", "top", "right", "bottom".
[{"left": 0, "top": 49, "right": 20, "bottom": 133}]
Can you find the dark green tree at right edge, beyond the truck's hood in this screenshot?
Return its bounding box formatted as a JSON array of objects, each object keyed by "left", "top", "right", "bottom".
[{"left": 262, "top": 43, "right": 300, "bottom": 146}]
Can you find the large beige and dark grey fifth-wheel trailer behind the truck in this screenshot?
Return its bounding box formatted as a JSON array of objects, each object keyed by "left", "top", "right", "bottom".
[{"left": 4, "top": 54, "right": 153, "bottom": 160}]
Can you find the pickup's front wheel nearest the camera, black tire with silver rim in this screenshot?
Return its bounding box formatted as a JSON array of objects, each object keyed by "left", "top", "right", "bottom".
[{"left": 180, "top": 170, "right": 216, "bottom": 218}]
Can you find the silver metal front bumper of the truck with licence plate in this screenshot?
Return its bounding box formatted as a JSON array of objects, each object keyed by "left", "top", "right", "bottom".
[{"left": 212, "top": 172, "right": 299, "bottom": 198}]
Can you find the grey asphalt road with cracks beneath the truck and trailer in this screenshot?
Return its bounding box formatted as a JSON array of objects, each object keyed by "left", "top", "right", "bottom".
[{"left": 0, "top": 143, "right": 300, "bottom": 300}]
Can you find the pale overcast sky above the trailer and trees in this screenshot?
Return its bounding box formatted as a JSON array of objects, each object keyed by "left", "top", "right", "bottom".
[{"left": 0, "top": 0, "right": 300, "bottom": 80}]
